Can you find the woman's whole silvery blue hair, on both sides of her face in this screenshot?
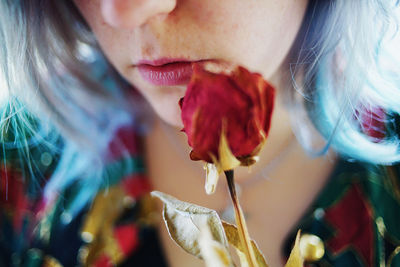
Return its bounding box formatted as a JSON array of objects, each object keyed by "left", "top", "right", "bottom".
[{"left": 0, "top": 0, "right": 400, "bottom": 216}]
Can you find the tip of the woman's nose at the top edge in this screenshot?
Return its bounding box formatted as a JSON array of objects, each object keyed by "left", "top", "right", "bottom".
[{"left": 101, "top": 0, "right": 176, "bottom": 28}]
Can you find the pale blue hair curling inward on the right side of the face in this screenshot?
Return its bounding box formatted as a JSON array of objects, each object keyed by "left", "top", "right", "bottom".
[{"left": 289, "top": 0, "right": 400, "bottom": 164}]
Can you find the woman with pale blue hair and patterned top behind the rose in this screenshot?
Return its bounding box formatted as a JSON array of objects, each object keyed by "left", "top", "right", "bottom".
[{"left": 0, "top": 0, "right": 400, "bottom": 266}]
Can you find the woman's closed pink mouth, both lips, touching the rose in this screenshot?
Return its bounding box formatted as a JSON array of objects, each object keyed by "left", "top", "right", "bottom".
[{"left": 136, "top": 58, "right": 206, "bottom": 86}]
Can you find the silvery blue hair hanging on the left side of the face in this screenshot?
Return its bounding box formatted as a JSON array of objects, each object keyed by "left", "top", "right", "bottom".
[{"left": 0, "top": 0, "right": 142, "bottom": 218}]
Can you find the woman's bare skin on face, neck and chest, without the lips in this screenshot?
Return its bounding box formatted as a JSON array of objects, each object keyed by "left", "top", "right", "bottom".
[{"left": 74, "top": 0, "right": 334, "bottom": 267}]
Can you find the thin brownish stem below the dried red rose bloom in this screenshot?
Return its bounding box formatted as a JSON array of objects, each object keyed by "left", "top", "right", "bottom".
[{"left": 225, "top": 170, "right": 258, "bottom": 267}]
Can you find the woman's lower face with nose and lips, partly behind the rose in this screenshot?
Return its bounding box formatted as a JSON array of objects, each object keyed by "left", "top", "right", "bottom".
[{"left": 75, "top": 0, "right": 308, "bottom": 126}]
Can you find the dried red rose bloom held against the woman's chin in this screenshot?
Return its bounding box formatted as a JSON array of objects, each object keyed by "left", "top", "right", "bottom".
[{"left": 179, "top": 65, "right": 275, "bottom": 170}]
